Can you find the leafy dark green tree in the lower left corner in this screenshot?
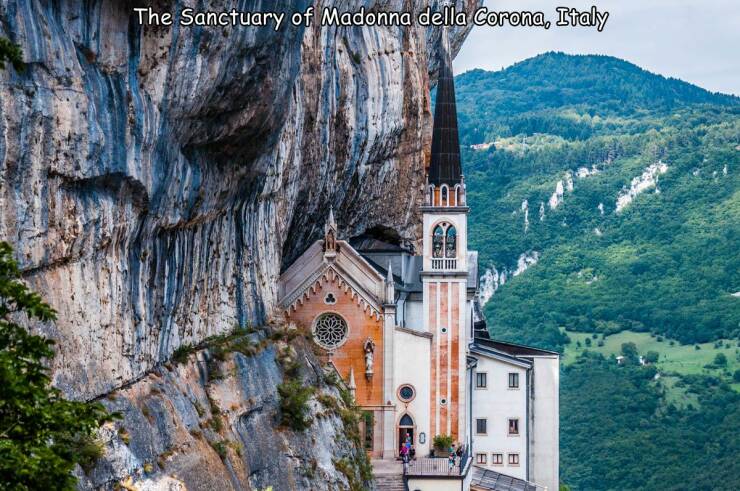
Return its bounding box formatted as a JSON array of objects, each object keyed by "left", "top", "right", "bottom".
[{"left": 0, "top": 242, "right": 114, "bottom": 490}]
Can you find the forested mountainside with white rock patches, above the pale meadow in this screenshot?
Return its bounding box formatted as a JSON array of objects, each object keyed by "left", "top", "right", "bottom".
[{"left": 457, "top": 54, "right": 740, "bottom": 348}]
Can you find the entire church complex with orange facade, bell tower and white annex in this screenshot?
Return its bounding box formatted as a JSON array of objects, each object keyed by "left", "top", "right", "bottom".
[{"left": 279, "top": 22, "right": 559, "bottom": 490}]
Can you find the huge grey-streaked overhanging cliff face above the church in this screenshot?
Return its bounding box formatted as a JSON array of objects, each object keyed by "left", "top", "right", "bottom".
[{"left": 0, "top": 0, "right": 477, "bottom": 398}]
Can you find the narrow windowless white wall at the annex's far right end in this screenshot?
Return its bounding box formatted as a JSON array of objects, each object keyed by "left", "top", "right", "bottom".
[{"left": 531, "top": 356, "right": 560, "bottom": 490}]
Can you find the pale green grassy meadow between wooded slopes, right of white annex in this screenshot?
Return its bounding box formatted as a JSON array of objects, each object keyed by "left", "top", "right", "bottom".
[{"left": 563, "top": 331, "right": 740, "bottom": 391}]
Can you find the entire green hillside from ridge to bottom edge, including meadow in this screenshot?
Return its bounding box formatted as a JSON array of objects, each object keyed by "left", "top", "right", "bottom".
[{"left": 456, "top": 53, "right": 740, "bottom": 490}]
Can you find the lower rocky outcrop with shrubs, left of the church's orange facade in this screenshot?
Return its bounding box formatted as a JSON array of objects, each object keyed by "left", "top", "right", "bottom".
[{"left": 78, "top": 331, "right": 371, "bottom": 491}]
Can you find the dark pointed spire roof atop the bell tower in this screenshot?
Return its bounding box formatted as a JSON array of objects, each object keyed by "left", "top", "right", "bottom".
[{"left": 429, "top": 23, "right": 462, "bottom": 186}]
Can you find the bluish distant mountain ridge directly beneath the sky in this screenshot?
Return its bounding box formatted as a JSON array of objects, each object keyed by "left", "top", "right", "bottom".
[{"left": 455, "top": 53, "right": 740, "bottom": 144}]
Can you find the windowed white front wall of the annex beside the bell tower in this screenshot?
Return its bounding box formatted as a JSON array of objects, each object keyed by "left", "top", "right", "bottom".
[{"left": 471, "top": 356, "right": 527, "bottom": 479}]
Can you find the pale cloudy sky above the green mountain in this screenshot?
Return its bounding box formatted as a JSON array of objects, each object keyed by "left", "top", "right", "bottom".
[{"left": 455, "top": 0, "right": 740, "bottom": 95}]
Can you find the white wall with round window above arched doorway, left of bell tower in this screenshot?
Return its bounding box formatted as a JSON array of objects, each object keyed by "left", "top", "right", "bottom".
[{"left": 391, "top": 329, "right": 433, "bottom": 457}]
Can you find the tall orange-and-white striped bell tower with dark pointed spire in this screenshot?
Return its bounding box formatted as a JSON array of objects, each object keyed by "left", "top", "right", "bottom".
[{"left": 421, "top": 18, "right": 469, "bottom": 442}]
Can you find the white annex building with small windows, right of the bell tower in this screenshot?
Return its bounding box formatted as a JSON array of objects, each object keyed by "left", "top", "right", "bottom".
[{"left": 470, "top": 330, "right": 559, "bottom": 489}]
